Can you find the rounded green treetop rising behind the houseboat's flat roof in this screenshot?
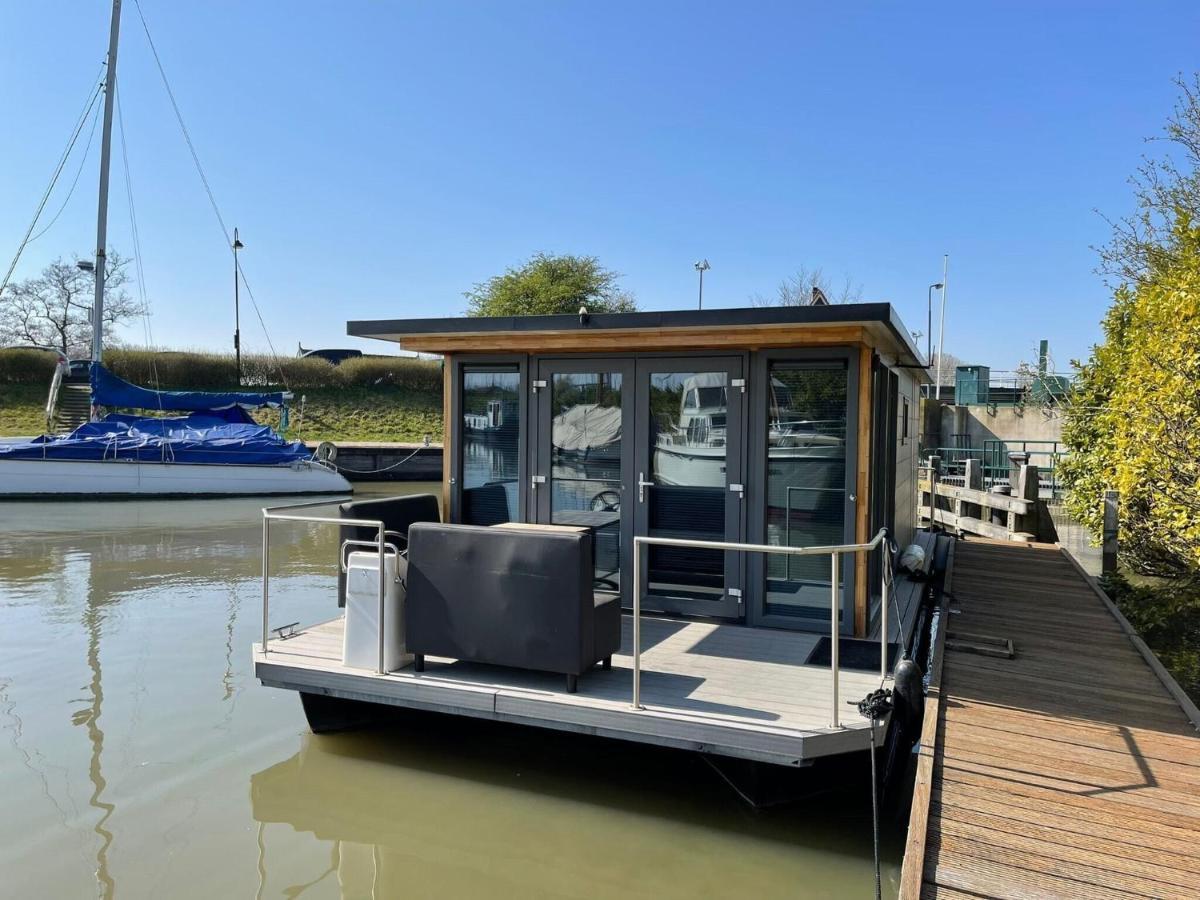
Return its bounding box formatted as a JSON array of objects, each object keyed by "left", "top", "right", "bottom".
[{"left": 463, "top": 253, "right": 637, "bottom": 316}]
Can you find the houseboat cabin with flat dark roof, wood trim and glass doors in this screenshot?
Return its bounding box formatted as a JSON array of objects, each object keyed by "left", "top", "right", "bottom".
[{"left": 348, "top": 304, "right": 926, "bottom": 638}]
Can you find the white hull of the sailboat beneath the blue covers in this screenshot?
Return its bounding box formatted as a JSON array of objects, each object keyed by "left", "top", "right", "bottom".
[{"left": 0, "top": 460, "right": 353, "bottom": 499}]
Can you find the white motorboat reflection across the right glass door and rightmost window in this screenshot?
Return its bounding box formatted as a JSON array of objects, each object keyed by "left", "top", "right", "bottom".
[{"left": 654, "top": 373, "right": 846, "bottom": 512}]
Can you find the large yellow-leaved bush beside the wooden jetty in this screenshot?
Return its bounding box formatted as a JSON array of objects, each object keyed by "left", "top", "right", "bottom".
[{"left": 1063, "top": 210, "right": 1200, "bottom": 578}]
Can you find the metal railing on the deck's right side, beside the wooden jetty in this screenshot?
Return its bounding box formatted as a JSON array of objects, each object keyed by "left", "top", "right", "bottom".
[{"left": 634, "top": 528, "right": 892, "bottom": 728}]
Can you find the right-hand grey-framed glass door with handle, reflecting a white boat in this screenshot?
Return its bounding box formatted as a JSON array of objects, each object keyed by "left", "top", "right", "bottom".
[{"left": 634, "top": 359, "right": 744, "bottom": 618}]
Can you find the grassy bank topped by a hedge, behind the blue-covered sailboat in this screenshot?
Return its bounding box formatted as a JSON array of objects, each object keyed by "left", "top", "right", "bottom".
[{"left": 0, "top": 349, "right": 442, "bottom": 442}]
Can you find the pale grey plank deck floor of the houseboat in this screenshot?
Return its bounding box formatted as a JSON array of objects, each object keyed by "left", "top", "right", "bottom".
[{"left": 254, "top": 616, "right": 883, "bottom": 766}]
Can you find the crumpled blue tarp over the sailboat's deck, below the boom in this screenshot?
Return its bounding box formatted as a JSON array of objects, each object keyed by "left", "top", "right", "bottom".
[{"left": 0, "top": 407, "right": 312, "bottom": 466}]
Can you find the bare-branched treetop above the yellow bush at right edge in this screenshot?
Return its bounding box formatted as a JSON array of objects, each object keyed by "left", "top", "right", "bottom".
[{"left": 1097, "top": 72, "right": 1200, "bottom": 284}]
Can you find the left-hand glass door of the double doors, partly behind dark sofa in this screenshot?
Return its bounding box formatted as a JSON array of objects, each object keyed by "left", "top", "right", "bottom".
[{"left": 533, "top": 360, "right": 634, "bottom": 593}]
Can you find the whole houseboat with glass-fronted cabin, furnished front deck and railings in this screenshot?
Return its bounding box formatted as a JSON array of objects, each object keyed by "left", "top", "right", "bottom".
[{"left": 254, "top": 304, "right": 936, "bottom": 767}]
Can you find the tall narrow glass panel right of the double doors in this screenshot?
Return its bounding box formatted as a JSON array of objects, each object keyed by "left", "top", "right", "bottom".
[{"left": 755, "top": 359, "right": 854, "bottom": 628}]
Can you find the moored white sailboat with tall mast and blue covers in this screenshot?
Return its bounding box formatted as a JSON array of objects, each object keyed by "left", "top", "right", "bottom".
[{"left": 0, "top": 0, "right": 352, "bottom": 499}]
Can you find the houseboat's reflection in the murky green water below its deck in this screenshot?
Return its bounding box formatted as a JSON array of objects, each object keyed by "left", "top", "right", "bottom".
[{"left": 250, "top": 713, "right": 898, "bottom": 898}]
